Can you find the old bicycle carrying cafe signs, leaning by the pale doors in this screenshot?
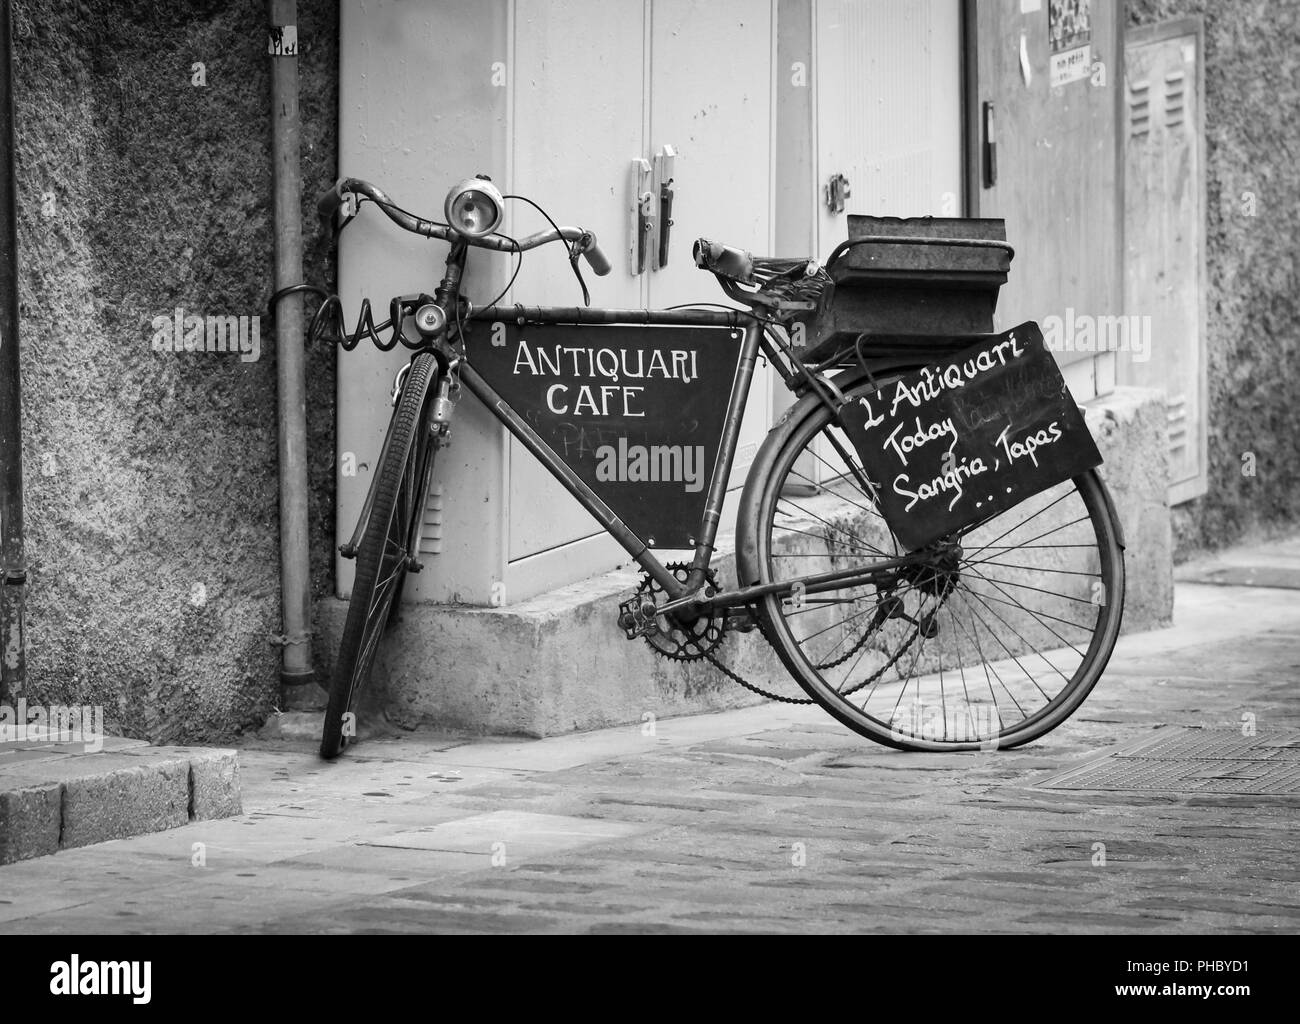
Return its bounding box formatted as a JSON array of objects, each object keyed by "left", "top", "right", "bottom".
[{"left": 272, "top": 175, "right": 1125, "bottom": 758}]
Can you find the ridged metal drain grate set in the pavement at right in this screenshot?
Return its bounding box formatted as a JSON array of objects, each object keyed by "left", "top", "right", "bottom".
[{"left": 1036, "top": 729, "right": 1300, "bottom": 797}]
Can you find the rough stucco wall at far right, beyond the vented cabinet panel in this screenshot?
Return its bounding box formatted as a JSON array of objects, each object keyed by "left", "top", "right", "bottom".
[{"left": 1127, "top": 0, "right": 1300, "bottom": 557}]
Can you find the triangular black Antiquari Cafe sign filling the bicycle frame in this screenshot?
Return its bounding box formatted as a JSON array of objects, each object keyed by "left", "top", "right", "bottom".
[{"left": 469, "top": 324, "right": 742, "bottom": 548}]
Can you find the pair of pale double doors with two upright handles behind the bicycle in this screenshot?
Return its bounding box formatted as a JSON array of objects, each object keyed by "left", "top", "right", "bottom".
[{"left": 507, "top": 0, "right": 772, "bottom": 602}]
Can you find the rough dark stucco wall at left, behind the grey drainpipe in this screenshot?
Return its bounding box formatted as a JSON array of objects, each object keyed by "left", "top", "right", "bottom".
[{"left": 14, "top": 0, "right": 338, "bottom": 741}]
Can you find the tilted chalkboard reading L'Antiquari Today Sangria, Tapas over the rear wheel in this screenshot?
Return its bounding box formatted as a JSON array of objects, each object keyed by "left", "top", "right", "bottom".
[{"left": 841, "top": 324, "right": 1101, "bottom": 550}]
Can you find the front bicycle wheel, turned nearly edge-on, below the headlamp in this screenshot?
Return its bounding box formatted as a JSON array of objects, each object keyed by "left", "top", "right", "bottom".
[{"left": 321, "top": 353, "right": 437, "bottom": 758}]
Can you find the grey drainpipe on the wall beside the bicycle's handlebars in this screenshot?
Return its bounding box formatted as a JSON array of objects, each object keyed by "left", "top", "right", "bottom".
[{"left": 268, "top": 0, "right": 316, "bottom": 703}]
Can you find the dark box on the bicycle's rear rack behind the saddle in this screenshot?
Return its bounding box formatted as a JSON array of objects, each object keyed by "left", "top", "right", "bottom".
[{"left": 805, "top": 214, "right": 1013, "bottom": 364}]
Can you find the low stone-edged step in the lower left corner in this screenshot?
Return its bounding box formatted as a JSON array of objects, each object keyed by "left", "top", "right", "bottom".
[{"left": 0, "top": 737, "right": 242, "bottom": 864}]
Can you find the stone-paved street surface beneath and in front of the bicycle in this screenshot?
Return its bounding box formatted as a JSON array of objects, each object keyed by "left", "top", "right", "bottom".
[{"left": 0, "top": 582, "right": 1300, "bottom": 933}]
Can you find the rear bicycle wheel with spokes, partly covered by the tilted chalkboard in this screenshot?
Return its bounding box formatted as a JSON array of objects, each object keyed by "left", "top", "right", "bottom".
[{"left": 754, "top": 383, "right": 1125, "bottom": 751}]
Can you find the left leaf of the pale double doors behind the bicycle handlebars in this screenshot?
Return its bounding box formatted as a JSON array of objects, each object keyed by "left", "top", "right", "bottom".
[{"left": 506, "top": 0, "right": 645, "bottom": 600}]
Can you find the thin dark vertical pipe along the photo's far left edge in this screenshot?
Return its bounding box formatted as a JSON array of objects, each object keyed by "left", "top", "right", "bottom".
[{"left": 0, "top": 0, "right": 27, "bottom": 704}]
